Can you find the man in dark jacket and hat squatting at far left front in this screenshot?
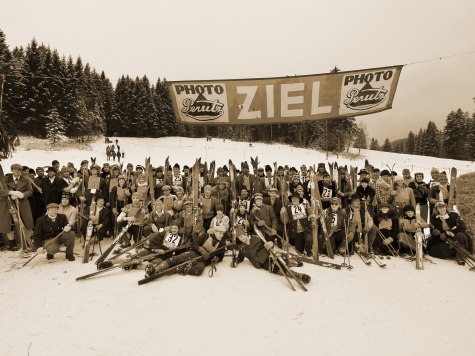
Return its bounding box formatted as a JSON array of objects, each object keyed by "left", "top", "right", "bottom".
[{"left": 33, "top": 203, "right": 75, "bottom": 261}]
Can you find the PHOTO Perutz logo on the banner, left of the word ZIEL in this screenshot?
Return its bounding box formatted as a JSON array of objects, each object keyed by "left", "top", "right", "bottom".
[{"left": 175, "top": 84, "right": 224, "bottom": 121}]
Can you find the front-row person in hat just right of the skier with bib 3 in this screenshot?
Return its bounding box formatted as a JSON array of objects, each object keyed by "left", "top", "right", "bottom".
[{"left": 345, "top": 193, "right": 376, "bottom": 253}]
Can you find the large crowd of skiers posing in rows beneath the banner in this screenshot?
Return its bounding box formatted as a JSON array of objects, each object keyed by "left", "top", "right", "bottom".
[{"left": 0, "top": 160, "right": 473, "bottom": 274}]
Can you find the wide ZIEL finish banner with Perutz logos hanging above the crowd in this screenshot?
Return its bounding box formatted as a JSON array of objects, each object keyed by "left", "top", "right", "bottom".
[{"left": 168, "top": 66, "right": 402, "bottom": 125}]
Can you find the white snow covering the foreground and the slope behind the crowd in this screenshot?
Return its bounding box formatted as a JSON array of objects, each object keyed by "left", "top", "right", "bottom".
[{"left": 0, "top": 137, "right": 475, "bottom": 356}]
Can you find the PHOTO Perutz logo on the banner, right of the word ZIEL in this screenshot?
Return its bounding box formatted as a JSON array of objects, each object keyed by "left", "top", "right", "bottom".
[{"left": 343, "top": 70, "right": 393, "bottom": 110}]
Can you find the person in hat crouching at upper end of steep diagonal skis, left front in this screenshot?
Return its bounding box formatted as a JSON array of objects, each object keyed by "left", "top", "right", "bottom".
[{"left": 117, "top": 193, "right": 148, "bottom": 248}]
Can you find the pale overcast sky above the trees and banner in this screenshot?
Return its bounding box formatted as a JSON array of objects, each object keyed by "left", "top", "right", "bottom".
[{"left": 0, "top": 0, "right": 475, "bottom": 141}]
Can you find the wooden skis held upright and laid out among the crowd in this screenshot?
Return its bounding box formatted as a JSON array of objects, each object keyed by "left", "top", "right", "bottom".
[{"left": 0, "top": 157, "right": 475, "bottom": 291}]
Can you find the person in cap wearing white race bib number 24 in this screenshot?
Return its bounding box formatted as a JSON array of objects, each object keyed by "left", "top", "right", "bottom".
[{"left": 280, "top": 191, "right": 316, "bottom": 257}]
